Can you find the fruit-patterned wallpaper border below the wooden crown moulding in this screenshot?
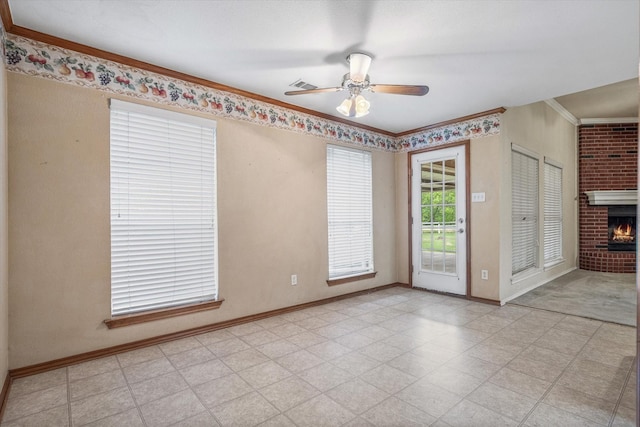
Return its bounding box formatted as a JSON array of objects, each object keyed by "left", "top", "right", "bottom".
[{"left": 3, "top": 34, "right": 500, "bottom": 152}]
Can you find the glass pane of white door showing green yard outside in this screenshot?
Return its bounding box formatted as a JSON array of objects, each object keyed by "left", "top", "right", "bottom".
[{"left": 421, "top": 159, "right": 457, "bottom": 274}]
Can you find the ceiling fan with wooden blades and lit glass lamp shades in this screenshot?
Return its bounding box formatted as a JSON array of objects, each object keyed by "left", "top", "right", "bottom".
[{"left": 284, "top": 52, "right": 429, "bottom": 117}]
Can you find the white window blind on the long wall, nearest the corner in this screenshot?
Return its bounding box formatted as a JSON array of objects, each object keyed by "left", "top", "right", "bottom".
[{"left": 327, "top": 145, "right": 373, "bottom": 279}]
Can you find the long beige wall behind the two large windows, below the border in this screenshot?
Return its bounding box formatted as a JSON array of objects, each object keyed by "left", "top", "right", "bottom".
[{"left": 8, "top": 73, "right": 397, "bottom": 368}]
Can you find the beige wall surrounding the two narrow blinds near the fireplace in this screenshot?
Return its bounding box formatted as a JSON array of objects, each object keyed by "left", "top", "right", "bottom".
[{"left": 500, "top": 102, "right": 578, "bottom": 302}]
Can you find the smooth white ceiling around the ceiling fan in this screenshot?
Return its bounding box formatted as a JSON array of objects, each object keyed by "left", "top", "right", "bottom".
[{"left": 9, "top": 0, "right": 640, "bottom": 132}]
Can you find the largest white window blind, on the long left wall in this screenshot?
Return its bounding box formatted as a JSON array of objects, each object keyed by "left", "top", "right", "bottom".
[{"left": 111, "top": 99, "right": 218, "bottom": 316}]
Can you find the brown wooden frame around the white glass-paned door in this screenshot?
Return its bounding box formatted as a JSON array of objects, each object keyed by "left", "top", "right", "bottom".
[{"left": 407, "top": 139, "right": 472, "bottom": 299}]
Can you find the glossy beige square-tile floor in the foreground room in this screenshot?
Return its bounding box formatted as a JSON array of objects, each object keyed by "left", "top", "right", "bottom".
[{"left": 1, "top": 288, "right": 636, "bottom": 427}]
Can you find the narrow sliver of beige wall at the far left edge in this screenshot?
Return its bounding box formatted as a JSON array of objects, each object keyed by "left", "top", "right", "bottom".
[{"left": 0, "top": 40, "right": 9, "bottom": 387}]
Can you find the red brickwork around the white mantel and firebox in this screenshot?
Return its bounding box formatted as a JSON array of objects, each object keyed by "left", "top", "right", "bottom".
[{"left": 578, "top": 124, "right": 638, "bottom": 273}]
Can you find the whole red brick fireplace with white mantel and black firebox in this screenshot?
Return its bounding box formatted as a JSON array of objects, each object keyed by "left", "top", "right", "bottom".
[{"left": 578, "top": 123, "right": 638, "bottom": 273}]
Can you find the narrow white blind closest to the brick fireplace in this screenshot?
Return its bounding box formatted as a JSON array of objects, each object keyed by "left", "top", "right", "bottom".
[{"left": 543, "top": 160, "right": 562, "bottom": 265}]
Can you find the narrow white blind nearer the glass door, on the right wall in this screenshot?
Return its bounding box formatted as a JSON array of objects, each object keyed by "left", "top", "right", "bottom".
[{"left": 511, "top": 150, "right": 538, "bottom": 274}]
